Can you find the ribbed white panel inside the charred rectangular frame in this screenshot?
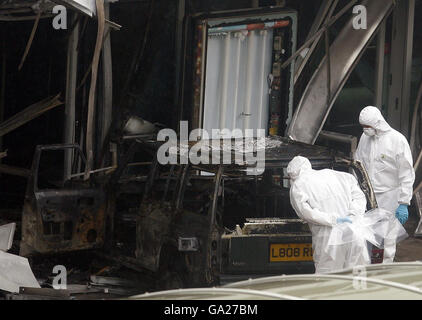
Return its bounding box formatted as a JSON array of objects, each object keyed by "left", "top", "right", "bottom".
[{"left": 203, "top": 29, "right": 273, "bottom": 138}]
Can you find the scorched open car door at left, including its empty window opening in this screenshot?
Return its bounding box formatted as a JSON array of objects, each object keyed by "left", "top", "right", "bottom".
[{"left": 20, "top": 144, "right": 112, "bottom": 256}]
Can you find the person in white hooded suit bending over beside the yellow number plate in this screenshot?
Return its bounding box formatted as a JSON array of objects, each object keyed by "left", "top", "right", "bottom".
[{"left": 287, "top": 156, "right": 370, "bottom": 273}]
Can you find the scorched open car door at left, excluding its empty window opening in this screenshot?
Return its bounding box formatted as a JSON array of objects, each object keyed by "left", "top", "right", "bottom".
[{"left": 20, "top": 144, "right": 109, "bottom": 256}]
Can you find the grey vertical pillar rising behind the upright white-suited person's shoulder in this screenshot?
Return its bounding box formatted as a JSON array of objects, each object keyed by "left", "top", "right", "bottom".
[{"left": 387, "top": 0, "right": 415, "bottom": 137}]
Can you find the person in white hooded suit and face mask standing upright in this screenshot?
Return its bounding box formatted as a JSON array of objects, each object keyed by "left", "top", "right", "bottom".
[{"left": 355, "top": 106, "right": 415, "bottom": 263}]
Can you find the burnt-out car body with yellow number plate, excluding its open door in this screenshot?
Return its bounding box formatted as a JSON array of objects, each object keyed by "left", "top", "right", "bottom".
[{"left": 136, "top": 137, "right": 377, "bottom": 287}]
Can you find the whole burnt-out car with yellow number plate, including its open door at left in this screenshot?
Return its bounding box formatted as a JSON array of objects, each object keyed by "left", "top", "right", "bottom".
[{"left": 20, "top": 137, "right": 376, "bottom": 287}]
